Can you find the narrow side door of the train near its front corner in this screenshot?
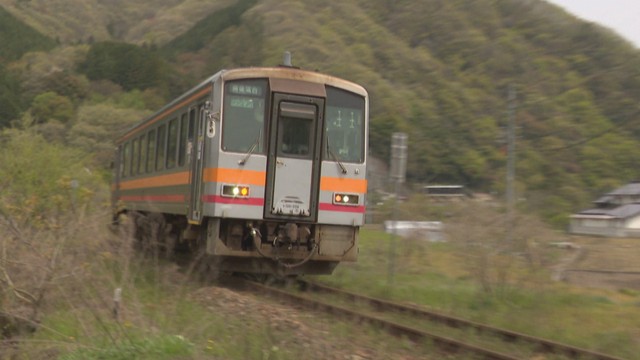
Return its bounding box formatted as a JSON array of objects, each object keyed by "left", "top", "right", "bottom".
[{"left": 187, "top": 105, "right": 205, "bottom": 224}]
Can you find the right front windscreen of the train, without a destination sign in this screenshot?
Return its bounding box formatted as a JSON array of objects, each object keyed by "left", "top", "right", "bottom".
[{"left": 324, "top": 86, "right": 365, "bottom": 163}]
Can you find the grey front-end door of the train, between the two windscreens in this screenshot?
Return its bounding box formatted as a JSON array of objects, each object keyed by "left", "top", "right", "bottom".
[{"left": 264, "top": 93, "right": 324, "bottom": 221}]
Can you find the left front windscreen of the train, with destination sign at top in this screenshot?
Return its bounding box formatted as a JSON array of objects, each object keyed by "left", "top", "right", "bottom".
[{"left": 222, "top": 79, "right": 268, "bottom": 154}]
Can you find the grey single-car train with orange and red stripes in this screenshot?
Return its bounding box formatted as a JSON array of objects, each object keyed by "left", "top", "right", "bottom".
[{"left": 111, "top": 56, "right": 369, "bottom": 276}]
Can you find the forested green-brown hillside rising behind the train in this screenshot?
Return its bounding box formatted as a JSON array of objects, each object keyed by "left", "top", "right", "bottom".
[{"left": 0, "top": 0, "right": 640, "bottom": 225}]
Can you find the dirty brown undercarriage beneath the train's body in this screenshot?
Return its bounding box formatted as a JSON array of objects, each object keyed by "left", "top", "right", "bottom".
[{"left": 118, "top": 212, "right": 358, "bottom": 276}]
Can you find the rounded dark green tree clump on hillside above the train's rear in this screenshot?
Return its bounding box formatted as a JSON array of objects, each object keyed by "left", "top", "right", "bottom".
[{"left": 80, "top": 41, "right": 167, "bottom": 91}]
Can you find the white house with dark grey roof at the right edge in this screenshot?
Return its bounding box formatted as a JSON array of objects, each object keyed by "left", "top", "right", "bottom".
[{"left": 569, "top": 181, "right": 640, "bottom": 237}]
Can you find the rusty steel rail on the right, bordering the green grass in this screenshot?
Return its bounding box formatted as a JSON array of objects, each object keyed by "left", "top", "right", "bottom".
[{"left": 298, "top": 280, "right": 623, "bottom": 360}]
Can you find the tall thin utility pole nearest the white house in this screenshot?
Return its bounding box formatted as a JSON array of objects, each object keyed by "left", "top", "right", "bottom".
[{"left": 506, "top": 84, "right": 516, "bottom": 247}]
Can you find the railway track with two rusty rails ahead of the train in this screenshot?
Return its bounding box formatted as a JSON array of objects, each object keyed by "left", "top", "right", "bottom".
[{"left": 239, "top": 281, "right": 620, "bottom": 360}]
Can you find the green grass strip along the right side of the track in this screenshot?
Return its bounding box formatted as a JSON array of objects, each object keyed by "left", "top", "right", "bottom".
[{"left": 314, "top": 228, "right": 640, "bottom": 359}]
